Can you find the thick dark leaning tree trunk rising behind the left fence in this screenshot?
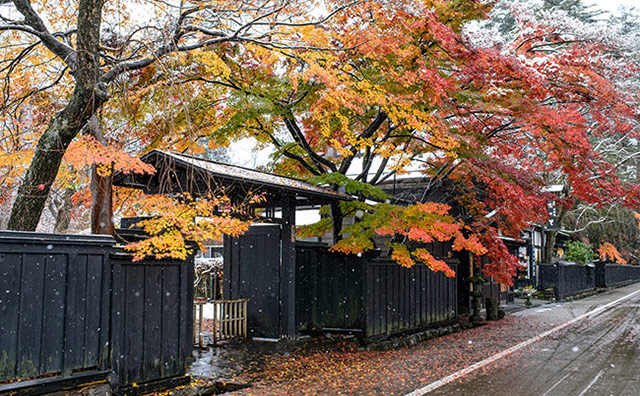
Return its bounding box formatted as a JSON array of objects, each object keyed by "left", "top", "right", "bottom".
[{"left": 7, "top": 0, "right": 108, "bottom": 231}]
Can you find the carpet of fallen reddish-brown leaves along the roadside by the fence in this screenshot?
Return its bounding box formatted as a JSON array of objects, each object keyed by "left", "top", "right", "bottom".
[{"left": 208, "top": 317, "right": 549, "bottom": 396}]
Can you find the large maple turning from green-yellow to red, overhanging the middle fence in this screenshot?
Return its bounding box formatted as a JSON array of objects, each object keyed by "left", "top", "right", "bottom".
[{"left": 158, "top": 1, "right": 638, "bottom": 283}]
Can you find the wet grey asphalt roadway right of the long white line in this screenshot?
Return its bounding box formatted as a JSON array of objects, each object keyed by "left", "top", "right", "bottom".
[{"left": 428, "top": 284, "right": 640, "bottom": 396}]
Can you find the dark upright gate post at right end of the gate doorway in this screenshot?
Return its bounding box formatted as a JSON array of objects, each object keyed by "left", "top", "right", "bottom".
[{"left": 280, "top": 195, "right": 296, "bottom": 338}]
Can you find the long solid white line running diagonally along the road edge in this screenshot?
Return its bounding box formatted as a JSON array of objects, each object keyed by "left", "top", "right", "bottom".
[{"left": 404, "top": 290, "right": 640, "bottom": 396}]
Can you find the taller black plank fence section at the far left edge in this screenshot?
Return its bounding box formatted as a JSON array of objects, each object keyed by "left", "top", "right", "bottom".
[{"left": 0, "top": 232, "right": 113, "bottom": 382}]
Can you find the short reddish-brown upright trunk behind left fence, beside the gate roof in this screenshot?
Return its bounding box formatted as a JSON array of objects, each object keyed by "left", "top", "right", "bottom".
[{"left": 87, "top": 115, "right": 115, "bottom": 235}]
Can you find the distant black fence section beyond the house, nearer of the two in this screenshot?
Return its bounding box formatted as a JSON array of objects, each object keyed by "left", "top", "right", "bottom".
[{"left": 538, "top": 263, "right": 596, "bottom": 298}]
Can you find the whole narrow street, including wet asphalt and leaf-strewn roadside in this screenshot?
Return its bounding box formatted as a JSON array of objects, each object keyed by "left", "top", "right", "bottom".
[{"left": 219, "top": 284, "right": 640, "bottom": 396}]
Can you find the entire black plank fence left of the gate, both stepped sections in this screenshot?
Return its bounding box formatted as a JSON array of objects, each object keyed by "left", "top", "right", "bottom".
[{"left": 0, "top": 232, "right": 193, "bottom": 394}]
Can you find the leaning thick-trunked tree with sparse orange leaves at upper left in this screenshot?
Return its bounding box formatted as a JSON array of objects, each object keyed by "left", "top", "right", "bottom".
[{"left": 0, "top": 0, "right": 356, "bottom": 230}]
